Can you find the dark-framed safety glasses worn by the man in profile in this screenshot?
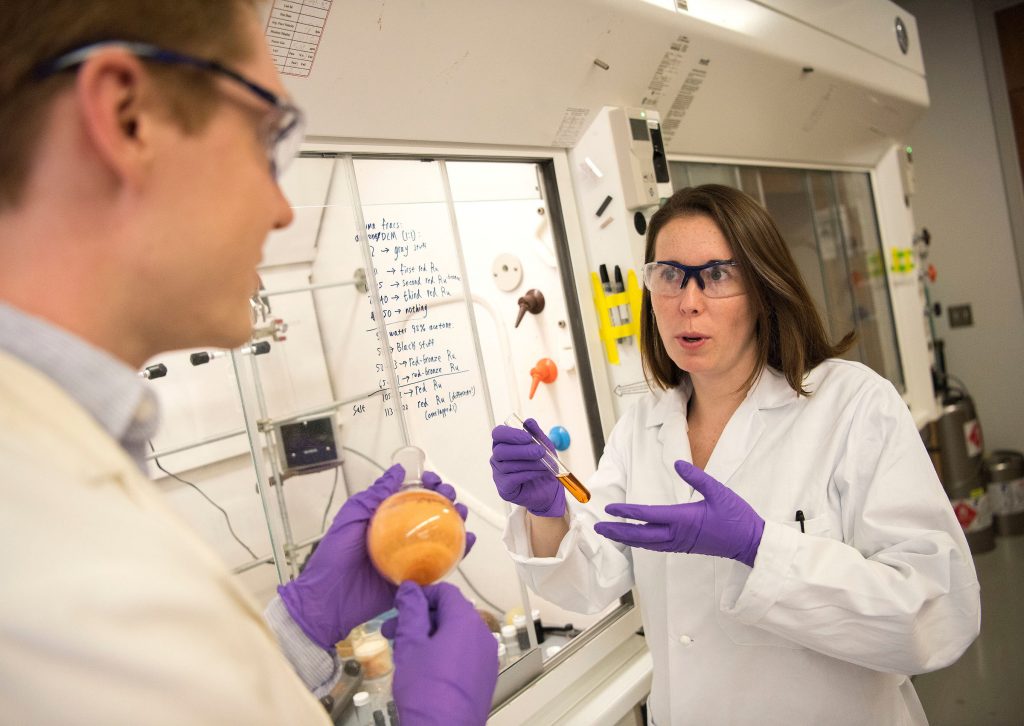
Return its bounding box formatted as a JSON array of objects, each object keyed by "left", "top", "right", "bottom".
[{"left": 34, "top": 40, "right": 305, "bottom": 177}]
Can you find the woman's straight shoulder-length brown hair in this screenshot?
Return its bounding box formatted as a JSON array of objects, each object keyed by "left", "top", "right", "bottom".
[{"left": 640, "top": 184, "right": 856, "bottom": 395}]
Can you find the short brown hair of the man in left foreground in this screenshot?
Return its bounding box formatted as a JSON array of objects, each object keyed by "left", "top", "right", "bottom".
[{"left": 0, "top": 0, "right": 255, "bottom": 209}]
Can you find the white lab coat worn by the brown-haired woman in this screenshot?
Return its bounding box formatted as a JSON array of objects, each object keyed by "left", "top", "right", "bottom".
[{"left": 505, "top": 360, "right": 980, "bottom": 726}]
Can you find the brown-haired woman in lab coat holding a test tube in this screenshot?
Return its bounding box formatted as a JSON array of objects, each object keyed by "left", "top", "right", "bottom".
[{"left": 490, "top": 185, "right": 980, "bottom": 726}]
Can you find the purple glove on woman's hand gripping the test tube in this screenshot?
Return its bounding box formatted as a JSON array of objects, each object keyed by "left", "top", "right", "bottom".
[{"left": 490, "top": 419, "right": 565, "bottom": 517}]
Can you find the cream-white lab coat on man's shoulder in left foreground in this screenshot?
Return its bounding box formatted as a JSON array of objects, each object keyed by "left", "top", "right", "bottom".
[{"left": 0, "top": 353, "right": 330, "bottom": 726}]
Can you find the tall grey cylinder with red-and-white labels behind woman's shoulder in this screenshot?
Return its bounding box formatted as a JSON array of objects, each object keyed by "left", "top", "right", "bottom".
[{"left": 928, "top": 390, "right": 995, "bottom": 554}]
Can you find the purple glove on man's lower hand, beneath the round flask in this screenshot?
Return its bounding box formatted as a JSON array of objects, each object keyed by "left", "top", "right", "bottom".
[{"left": 381, "top": 581, "right": 498, "bottom": 726}]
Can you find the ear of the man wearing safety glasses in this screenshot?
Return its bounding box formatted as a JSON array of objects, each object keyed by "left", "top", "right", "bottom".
[{"left": 75, "top": 48, "right": 156, "bottom": 185}]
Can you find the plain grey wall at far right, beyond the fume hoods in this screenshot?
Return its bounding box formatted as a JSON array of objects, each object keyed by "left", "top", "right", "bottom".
[{"left": 899, "top": 0, "right": 1024, "bottom": 451}]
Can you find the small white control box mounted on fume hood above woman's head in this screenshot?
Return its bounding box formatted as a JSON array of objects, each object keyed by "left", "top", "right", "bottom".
[{"left": 608, "top": 109, "right": 669, "bottom": 210}]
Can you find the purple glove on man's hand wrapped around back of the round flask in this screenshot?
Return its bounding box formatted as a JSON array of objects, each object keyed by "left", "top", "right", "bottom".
[{"left": 278, "top": 464, "right": 476, "bottom": 650}]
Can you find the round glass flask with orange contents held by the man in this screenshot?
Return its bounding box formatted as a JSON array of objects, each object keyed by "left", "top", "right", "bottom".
[{"left": 367, "top": 446, "right": 466, "bottom": 585}]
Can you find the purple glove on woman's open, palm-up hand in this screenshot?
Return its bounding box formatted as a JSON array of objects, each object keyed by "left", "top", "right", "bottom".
[{"left": 594, "top": 461, "right": 765, "bottom": 567}]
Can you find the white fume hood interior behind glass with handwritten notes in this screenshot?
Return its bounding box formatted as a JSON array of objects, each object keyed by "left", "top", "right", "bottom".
[{"left": 145, "top": 155, "right": 599, "bottom": 628}]
